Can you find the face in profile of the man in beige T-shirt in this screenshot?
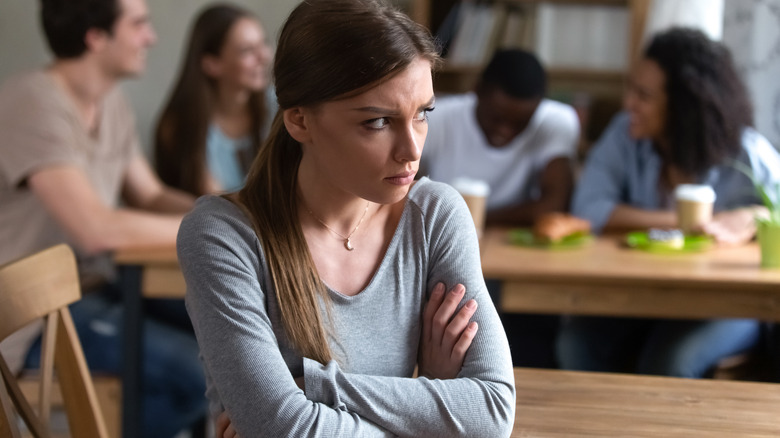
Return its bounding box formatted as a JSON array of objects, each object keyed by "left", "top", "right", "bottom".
[{"left": 96, "top": 0, "right": 157, "bottom": 77}]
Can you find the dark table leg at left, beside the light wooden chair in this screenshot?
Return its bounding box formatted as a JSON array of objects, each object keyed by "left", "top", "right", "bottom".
[{"left": 119, "top": 266, "right": 143, "bottom": 438}]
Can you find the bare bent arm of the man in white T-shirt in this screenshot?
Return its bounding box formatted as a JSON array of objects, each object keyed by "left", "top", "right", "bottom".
[{"left": 486, "top": 157, "right": 574, "bottom": 226}]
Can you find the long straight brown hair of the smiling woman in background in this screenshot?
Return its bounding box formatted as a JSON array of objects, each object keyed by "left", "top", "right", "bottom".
[{"left": 154, "top": 4, "right": 267, "bottom": 196}]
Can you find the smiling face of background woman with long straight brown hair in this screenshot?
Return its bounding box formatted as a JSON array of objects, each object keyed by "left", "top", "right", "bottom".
[{"left": 206, "top": 17, "right": 271, "bottom": 91}]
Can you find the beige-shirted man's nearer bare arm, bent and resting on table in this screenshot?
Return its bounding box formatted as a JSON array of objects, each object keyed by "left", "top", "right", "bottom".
[{"left": 27, "top": 165, "right": 190, "bottom": 253}]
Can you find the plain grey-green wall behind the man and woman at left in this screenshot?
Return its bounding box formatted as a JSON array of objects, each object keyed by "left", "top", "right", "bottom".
[{"left": 0, "top": 0, "right": 299, "bottom": 152}]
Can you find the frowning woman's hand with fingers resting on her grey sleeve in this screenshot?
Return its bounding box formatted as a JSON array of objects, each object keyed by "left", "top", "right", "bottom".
[{"left": 417, "top": 283, "right": 477, "bottom": 379}]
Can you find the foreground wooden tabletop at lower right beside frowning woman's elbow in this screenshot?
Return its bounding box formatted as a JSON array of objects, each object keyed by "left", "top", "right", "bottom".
[{"left": 511, "top": 368, "right": 780, "bottom": 438}]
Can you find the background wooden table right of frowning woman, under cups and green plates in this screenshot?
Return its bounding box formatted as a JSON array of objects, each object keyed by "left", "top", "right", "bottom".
[{"left": 481, "top": 229, "right": 780, "bottom": 321}]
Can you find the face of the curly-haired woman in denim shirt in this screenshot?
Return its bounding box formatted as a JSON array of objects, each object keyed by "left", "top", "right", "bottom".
[{"left": 623, "top": 59, "right": 667, "bottom": 139}]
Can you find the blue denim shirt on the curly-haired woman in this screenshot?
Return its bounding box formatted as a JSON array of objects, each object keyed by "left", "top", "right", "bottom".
[{"left": 572, "top": 113, "right": 780, "bottom": 233}]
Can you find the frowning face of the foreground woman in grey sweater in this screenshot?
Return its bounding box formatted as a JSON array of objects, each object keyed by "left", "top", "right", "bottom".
[{"left": 294, "top": 58, "right": 434, "bottom": 204}]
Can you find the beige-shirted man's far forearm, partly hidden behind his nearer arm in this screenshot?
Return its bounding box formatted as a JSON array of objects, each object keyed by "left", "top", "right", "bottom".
[{"left": 122, "top": 155, "right": 194, "bottom": 213}]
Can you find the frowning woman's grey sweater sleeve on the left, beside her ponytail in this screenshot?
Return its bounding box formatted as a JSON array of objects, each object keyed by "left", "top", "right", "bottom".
[{"left": 177, "top": 198, "right": 392, "bottom": 437}]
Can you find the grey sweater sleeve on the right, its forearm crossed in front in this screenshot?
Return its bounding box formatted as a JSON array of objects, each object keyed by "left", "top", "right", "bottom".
[{"left": 304, "top": 185, "right": 515, "bottom": 437}]
